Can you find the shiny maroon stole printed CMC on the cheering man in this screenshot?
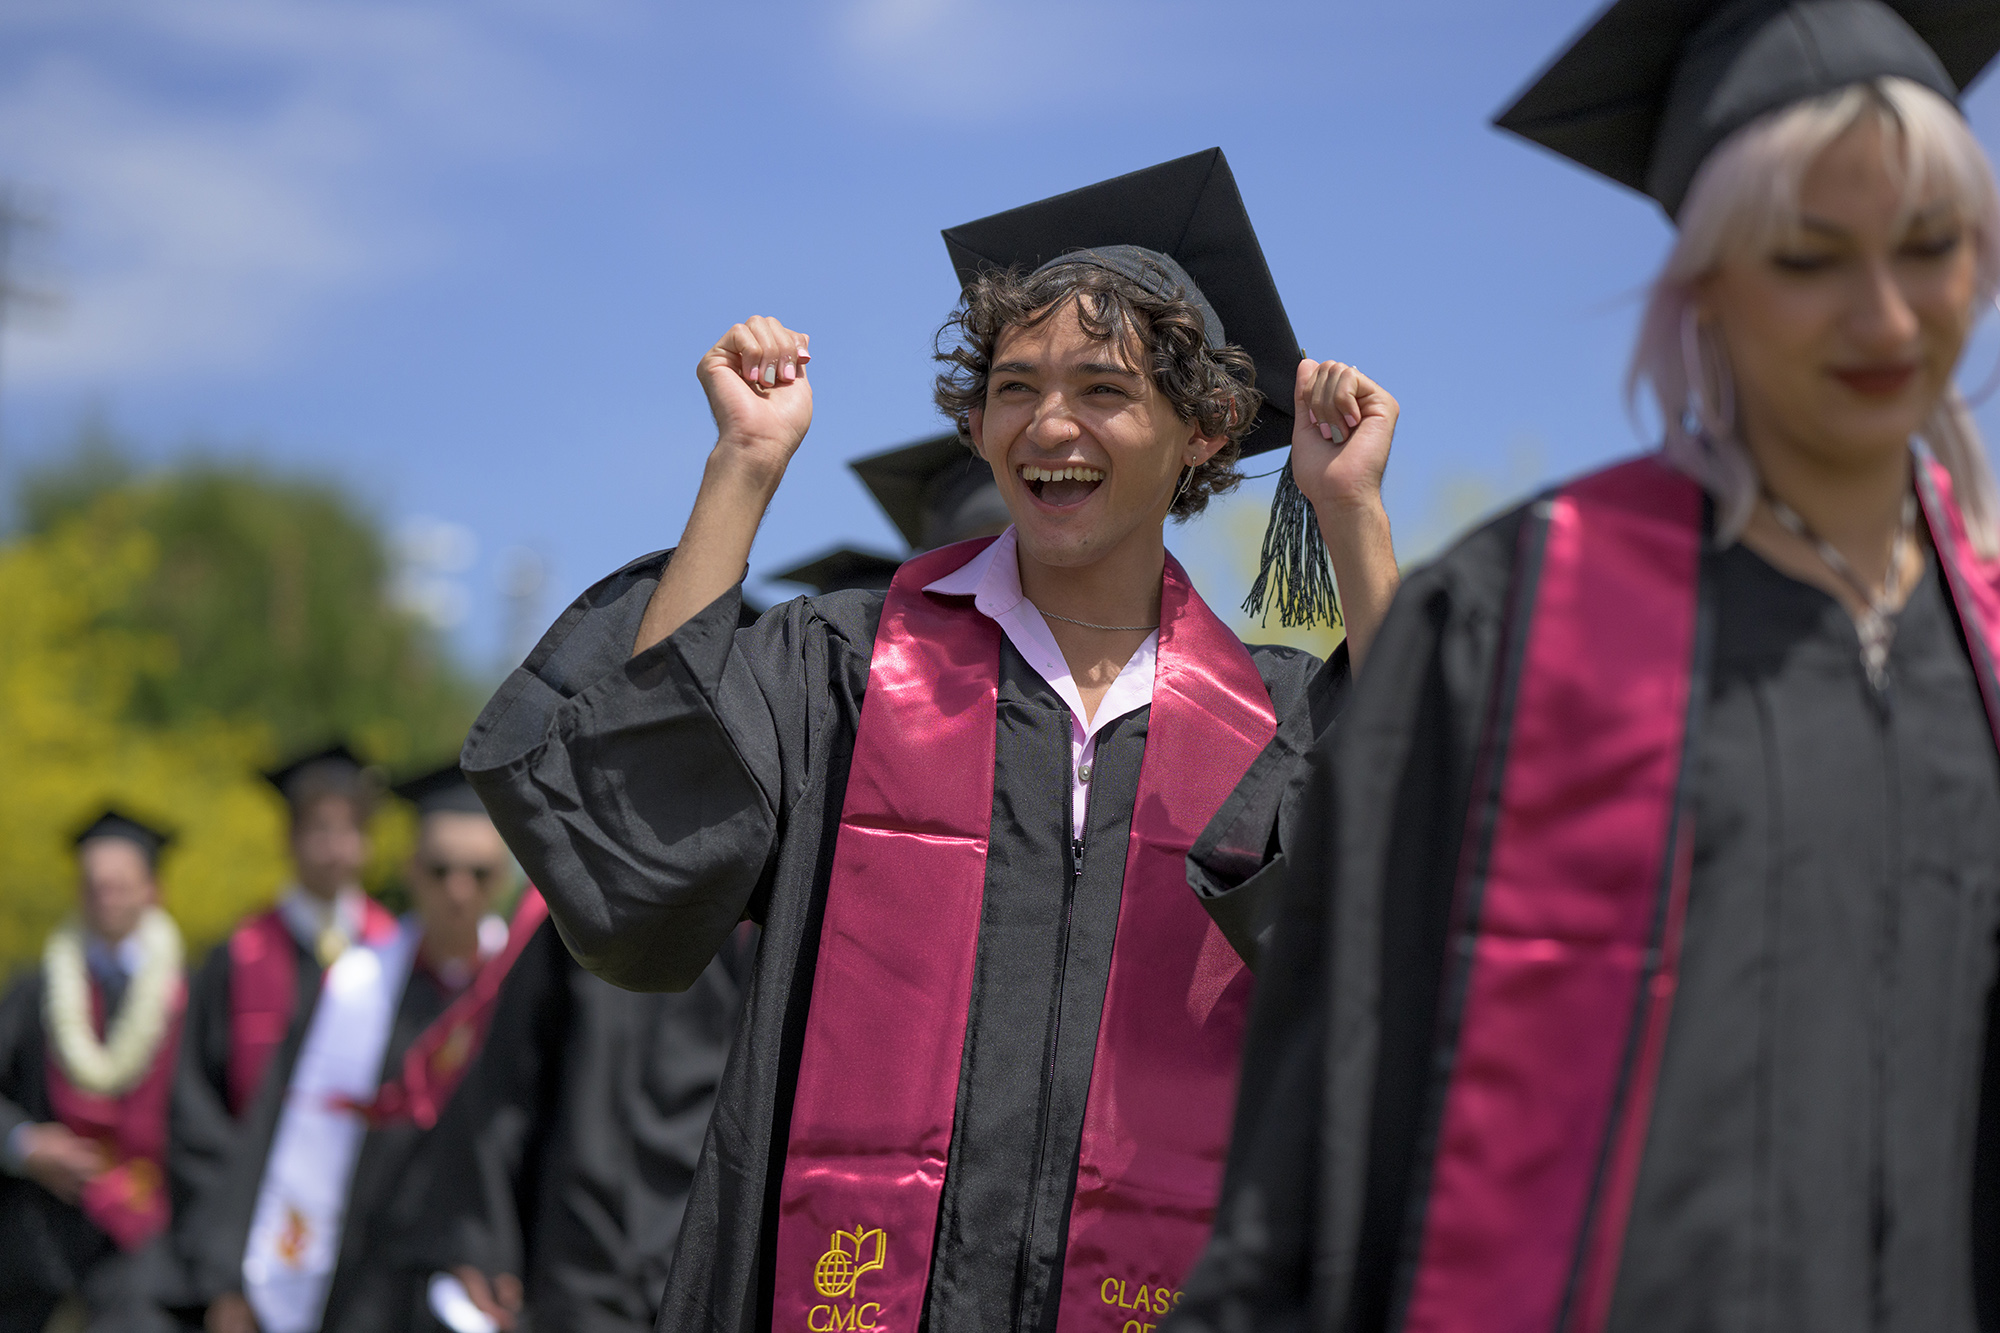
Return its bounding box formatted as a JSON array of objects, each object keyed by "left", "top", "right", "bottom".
[{"left": 774, "top": 542, "right": 1276, "bottom": 1333}]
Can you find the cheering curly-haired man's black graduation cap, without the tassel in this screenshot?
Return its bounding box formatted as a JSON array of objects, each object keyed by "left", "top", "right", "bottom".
[{"left": 944, "top": 148, "right": 1300, "bottom": 456}]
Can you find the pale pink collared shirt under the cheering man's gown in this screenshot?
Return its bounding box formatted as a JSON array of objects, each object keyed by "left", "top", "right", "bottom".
[{"left": 924, "top": 528, "right": 1160, "bottom": 839}]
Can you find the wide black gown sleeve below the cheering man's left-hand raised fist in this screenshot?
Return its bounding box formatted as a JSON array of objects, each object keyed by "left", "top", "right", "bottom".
[{"left": 464, "top": 552, "right": 880, "bottom": 991}]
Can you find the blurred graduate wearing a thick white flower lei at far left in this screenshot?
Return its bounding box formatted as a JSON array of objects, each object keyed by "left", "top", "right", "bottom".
[{"left": 0, "top": 811, "right": 188, "bottom": 1333}]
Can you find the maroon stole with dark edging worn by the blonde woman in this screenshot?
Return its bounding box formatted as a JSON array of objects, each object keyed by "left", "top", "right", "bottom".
[{"left": 1398, "top": 456, "right": 2000, "bottom": 1333}]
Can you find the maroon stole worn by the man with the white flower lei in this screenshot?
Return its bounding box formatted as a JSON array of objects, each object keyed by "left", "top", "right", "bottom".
[{"left": 44, "top": 977, "right": 188, "bottom": 1251}]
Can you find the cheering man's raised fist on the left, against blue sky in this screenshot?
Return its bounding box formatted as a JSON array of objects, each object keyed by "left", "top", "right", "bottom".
[{"left": 696, "top": 314, "right": 812, "bottom": 474}]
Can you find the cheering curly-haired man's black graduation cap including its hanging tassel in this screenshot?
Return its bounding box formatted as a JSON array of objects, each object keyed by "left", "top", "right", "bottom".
[{"left": 944, "top": 148, "right": 1340, "bottom": 624}]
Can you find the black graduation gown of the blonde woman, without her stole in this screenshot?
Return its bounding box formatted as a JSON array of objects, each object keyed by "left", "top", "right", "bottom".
[{"left": 1170, "top": 500, "right": 2000, "bottom": 1333}]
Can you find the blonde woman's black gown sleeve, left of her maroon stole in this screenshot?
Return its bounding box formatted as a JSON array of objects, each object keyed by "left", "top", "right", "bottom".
[{"left": 1168, "top": 512, "right": 1520, "bottom": 1333}]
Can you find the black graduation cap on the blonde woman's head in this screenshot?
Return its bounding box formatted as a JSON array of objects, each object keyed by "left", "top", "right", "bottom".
[{"left": 1494, "top": 0, "right": 2000, "bottom": 216}]
